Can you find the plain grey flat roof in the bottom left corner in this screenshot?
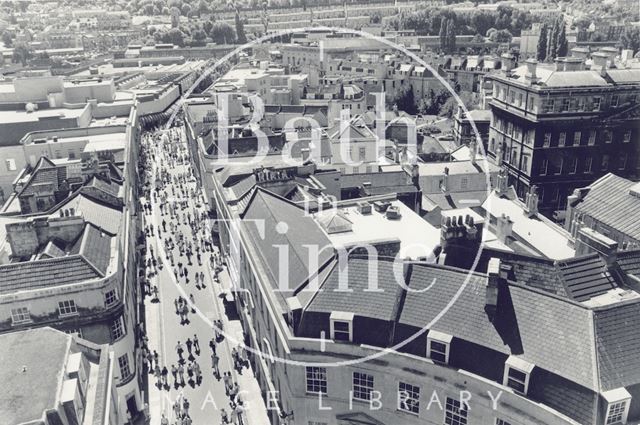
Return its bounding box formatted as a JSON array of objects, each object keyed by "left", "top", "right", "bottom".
[{"left": 0, "top": 327, "right": 71, "bottom": 424}]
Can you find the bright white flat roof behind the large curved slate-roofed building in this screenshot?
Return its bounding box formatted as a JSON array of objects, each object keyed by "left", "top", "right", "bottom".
[{"left": 315, "top": 200, "right": 440, "bottom": 260}]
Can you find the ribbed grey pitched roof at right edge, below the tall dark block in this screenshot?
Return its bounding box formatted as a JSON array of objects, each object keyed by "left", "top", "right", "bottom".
[{"left": 575, "top": 173, "right": 640, "bottom": 240}]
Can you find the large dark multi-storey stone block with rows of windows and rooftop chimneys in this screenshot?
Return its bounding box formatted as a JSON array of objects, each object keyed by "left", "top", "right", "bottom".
[{"left": 487, "top": 50, "right": 640, "bottom": 218}]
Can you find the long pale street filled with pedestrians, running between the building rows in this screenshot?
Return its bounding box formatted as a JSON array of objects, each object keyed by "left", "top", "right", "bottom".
[{"left": 141, "top": 123, "right": 269, "bottom": 425}]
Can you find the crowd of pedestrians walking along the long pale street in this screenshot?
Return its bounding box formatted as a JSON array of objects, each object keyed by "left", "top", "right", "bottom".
[{"left": 139, "top": 127, "right": 249, "bottom": 425}]
